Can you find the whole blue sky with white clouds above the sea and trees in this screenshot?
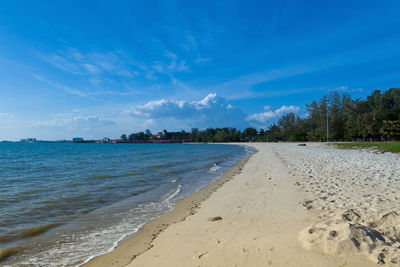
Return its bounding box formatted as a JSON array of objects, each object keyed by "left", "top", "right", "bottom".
[{"left": 0, "top": 0, "right": 400, "bottom": 140}]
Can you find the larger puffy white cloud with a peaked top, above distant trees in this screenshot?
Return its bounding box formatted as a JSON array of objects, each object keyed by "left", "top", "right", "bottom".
[{"left": 127, "top": 94, "right": 248, "bottom": 129}]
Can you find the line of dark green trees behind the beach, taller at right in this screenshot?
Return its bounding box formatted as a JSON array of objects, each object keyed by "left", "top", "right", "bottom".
[{"left": 121, "top": 88, "right": 400, "bottom": 142}]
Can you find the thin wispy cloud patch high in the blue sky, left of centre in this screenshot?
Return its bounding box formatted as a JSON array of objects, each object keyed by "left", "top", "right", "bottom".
[{"left": 41, "top": 48, "right": 195, "bottom": 89}]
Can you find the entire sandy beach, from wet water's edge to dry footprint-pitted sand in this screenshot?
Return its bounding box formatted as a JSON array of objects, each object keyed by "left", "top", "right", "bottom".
[{"left": 85, "top": 143, "right": 400, "bottom": 266}]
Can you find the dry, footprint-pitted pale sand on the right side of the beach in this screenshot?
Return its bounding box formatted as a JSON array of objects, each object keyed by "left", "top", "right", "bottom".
[{"left": 275, "top": 145, "right": 400, "bottom": 265}]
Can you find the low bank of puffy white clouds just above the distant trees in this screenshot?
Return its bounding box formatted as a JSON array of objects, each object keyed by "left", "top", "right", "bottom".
[{"left": 126, "top": 93, "right": 302, "bottom": 130}]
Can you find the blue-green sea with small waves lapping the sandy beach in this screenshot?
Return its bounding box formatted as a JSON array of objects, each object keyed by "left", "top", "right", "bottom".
[{"left": 0, "top": 143, "right": 251, "bottom": 266}]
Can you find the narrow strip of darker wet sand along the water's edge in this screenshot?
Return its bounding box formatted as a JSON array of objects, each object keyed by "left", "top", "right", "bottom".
[{"left": 80, "top": 147, "right": 258, "bottom": 267}]
